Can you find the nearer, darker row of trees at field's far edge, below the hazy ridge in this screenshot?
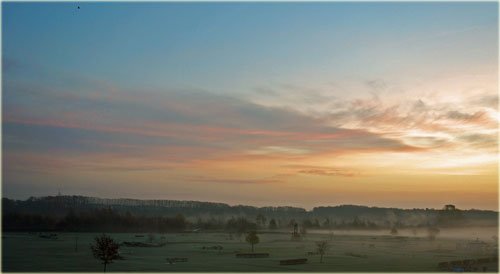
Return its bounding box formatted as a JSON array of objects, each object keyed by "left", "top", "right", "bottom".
[{"left": 3, "top": 208, "right": 470, "bottom": 233}]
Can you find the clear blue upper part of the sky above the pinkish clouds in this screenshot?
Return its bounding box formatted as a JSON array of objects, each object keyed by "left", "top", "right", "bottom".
[{"left": 3, "top": 2, "right": 498, "bottom": 93}]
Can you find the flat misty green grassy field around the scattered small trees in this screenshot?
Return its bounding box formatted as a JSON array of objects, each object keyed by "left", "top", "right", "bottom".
[{"left": 2, "top": 229, "right": 498, "bottom": 272}]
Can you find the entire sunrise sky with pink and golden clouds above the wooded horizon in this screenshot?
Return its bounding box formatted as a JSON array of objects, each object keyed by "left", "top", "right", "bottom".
[{"left": 2, "top": 2, "right": 500, "bottom": 210}]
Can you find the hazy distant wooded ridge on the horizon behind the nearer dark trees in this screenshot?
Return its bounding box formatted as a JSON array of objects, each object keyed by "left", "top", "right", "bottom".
[{"left": 2, "top": 196, "right": 498, "bottom": 230}]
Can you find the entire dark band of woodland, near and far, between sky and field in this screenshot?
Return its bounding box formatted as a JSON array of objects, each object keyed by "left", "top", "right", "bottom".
[{"left": 2, "top": 196, "right": 498, "bottom": 232}]
